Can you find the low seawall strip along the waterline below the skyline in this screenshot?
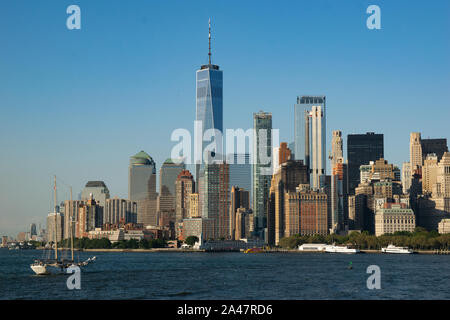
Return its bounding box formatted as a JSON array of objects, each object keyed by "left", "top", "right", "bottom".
[{"left": 36, "top": 247, "right": 450, "bottom": 255}]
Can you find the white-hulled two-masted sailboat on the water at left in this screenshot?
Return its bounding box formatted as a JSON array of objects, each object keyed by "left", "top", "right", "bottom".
[{"left": 30, "top": 176, "right": 96, "bottom": 275}]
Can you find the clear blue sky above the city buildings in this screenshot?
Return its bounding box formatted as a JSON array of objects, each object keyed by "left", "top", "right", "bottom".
[{"left": 0, "top": 0, "right": 450, "bottom": 236}]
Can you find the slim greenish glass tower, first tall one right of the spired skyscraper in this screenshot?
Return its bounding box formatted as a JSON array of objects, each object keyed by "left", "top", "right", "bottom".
[{"left": 253, "top": 111, "right": 272, "bottom": 238}]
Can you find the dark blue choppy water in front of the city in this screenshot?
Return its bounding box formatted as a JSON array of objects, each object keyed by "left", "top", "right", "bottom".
[{"left": 0, "top": 249, "right": 450, "bottom": 300}]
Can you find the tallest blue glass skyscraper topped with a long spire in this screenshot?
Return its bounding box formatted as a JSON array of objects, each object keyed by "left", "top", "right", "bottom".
[{"left": 196, "top": 21, "right": 223, "bottom": 183}]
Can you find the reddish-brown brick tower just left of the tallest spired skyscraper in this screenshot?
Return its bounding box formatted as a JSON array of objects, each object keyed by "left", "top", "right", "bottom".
[{"left": 175, "top": 170, "right": 195, "bottom": 222}]
